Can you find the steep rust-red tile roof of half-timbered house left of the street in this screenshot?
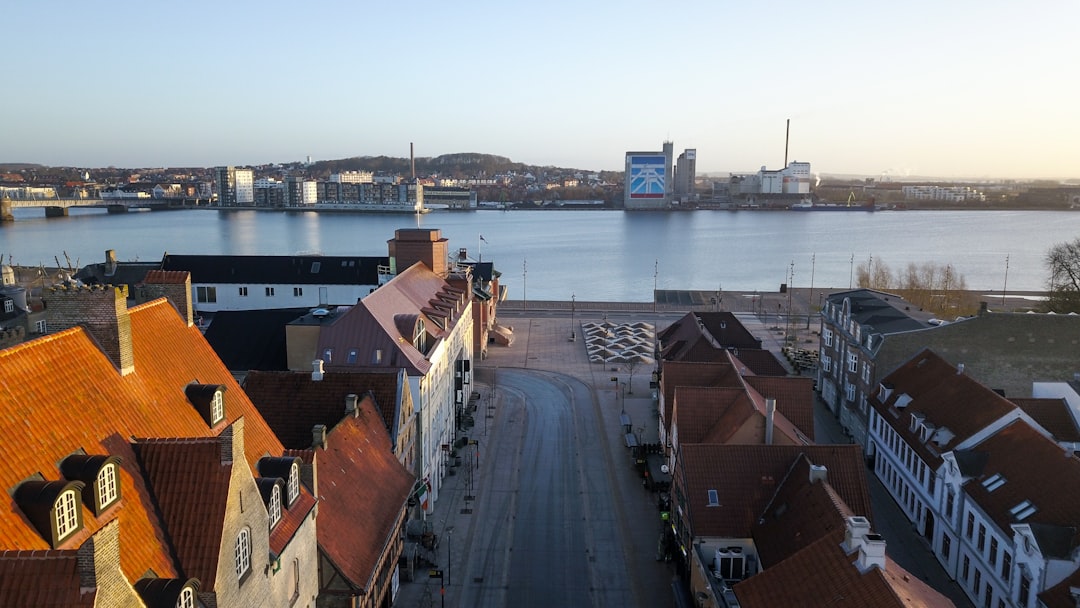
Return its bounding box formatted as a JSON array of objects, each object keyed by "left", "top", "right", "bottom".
[{"left": 315, "top": 398, "right": 416, "bottom": 592}]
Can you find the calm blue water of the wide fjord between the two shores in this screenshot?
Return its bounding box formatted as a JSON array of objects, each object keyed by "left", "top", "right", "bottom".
[{"left": 0, "top": 210, "right": 1080, "bottom": 301}]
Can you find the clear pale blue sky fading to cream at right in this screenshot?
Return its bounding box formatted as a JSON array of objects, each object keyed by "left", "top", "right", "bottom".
[{"left": 0, "top": 0, "right": 1080, "bottom": 179}]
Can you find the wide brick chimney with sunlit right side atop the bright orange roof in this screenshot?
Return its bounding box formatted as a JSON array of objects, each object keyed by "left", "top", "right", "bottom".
[{"left": 43, "top": 285, "right": 135, "bottom": 376}]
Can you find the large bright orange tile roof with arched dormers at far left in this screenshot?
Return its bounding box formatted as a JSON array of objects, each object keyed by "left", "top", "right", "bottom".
[{"left": 0, "top": 299, "right": 282, "bottom": 580}]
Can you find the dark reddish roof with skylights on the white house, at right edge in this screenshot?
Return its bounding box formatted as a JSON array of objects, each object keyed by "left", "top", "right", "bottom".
[{"left": 963, "top": 420, "right": 1080, "bottom": 553}]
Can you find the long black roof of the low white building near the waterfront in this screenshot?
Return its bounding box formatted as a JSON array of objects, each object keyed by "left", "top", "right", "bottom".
[{"left": 161, "top": 254, "right": 390, "bottom": 285}]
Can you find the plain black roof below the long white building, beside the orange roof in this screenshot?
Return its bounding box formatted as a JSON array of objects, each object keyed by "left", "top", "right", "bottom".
[{"left": 205, "top": 309, "right": 308, "bottom": 371}]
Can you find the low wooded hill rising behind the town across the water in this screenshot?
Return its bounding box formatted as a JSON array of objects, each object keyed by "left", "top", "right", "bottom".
[{"left": 308, "top": 152, "right": 527, "bottom": 177}]
